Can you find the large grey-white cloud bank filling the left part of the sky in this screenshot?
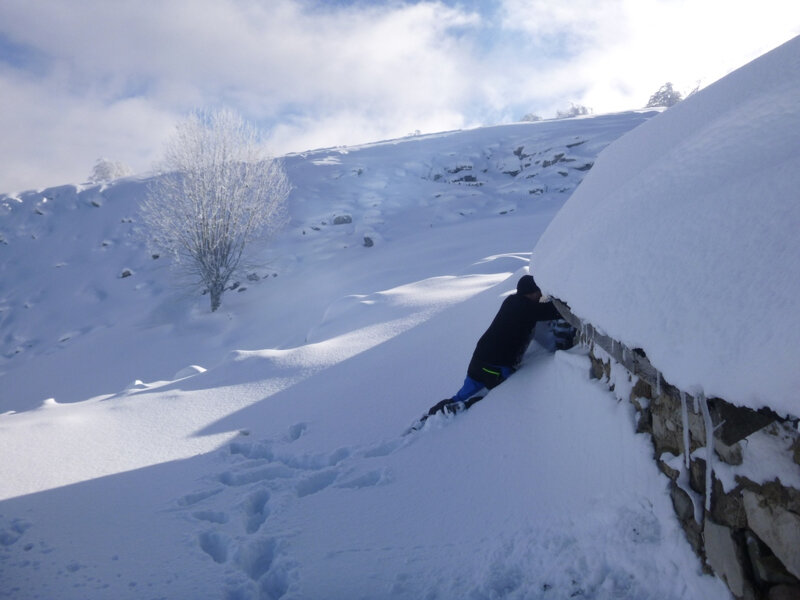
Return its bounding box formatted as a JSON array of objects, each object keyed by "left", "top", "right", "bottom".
[{"left": 0, "top": 0, "right": 488, "bottom": 190}]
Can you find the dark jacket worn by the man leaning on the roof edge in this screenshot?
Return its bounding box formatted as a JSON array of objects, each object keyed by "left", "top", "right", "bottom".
[{"left": 470, "top": 294, "right": 561, "bottom": 370}]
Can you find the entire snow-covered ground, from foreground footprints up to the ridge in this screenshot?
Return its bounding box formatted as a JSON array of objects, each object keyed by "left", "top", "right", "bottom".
[{"left": 0, "top": 113, "right": 729, "bottom": 600}]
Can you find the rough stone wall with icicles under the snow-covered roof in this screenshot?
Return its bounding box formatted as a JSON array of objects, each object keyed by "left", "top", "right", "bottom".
[{"left": 556, "top": 301, "right": 800, "bottom": 600}]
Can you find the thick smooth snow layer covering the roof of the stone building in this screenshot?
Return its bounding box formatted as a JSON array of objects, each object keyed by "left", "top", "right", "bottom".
[{"left": 532, "top": 37, "right": 800, "bottom": 415}]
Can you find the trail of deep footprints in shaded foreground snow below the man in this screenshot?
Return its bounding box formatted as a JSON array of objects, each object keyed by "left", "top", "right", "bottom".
[{"left": 177, "top": 422, "right": 410, "bottom": 599}]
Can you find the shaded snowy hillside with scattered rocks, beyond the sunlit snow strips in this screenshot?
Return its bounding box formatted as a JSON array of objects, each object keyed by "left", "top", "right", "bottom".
[{"left": 0, "top": 112, "right": 653, "bottom": 411}]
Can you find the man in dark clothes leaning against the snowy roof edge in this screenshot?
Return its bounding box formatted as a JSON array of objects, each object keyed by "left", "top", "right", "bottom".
[{"left": 422, "top": 275, "right": 561, "bottom": 422}]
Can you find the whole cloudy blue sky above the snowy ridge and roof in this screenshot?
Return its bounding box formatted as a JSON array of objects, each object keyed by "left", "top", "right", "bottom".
[{"left": 0, "top": 0, "right": 800, "bottom": 192}]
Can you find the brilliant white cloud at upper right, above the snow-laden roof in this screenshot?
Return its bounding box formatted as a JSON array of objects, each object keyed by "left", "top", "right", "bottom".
[{"left": 503, "top": 0, "right": 800, "bottom": 112}]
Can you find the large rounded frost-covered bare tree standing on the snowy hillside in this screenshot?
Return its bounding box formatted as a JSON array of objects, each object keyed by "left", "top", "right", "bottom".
[{"left": 142, "top": 110, "right": 290, "bottom": 312}]
